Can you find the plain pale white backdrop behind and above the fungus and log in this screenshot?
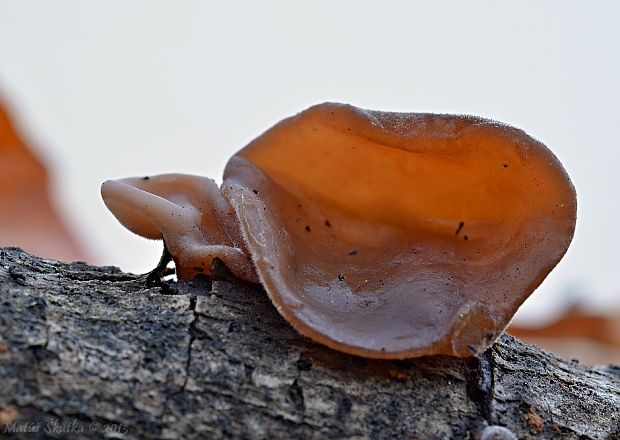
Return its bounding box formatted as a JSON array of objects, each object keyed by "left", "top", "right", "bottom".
[{"left": 0, "top": 0, "right": 620, "bottom": 321}]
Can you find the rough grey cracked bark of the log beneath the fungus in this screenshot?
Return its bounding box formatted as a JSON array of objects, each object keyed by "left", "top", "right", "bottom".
[{"left": 0, "top": 248, "right": 620, "bottom": 439}]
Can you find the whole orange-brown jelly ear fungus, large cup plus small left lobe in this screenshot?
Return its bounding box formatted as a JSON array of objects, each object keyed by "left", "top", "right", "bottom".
[{"left": 102, "top": 103, "right": 576, "bottom": 358}]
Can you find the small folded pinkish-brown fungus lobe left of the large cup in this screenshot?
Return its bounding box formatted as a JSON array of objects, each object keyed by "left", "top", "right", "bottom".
[{"left": 101, "top": 174, "right": 259, "bottom": 282}]
